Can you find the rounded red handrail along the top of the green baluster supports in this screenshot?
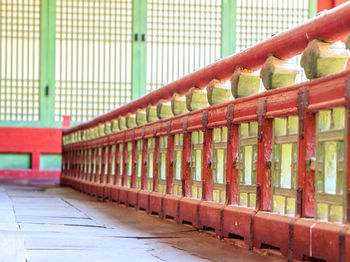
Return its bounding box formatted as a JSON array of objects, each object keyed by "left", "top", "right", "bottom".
[{"left": 63, "top": 2, "right": 350, "bottom": 135}]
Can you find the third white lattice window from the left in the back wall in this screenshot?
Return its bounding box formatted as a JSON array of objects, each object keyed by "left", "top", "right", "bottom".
[{"left": 146, "top": 0, "right": 222, "bottom": 92}]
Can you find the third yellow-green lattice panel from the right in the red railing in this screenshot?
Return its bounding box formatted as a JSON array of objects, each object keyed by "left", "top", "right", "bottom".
[{"left": 237, "top": 122, "right": 258, "bottom": 208}]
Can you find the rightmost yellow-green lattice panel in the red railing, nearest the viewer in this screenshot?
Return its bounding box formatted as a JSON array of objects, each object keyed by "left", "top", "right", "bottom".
[{"left": 315, "top": 107, "right": 347, "bottom": 222}]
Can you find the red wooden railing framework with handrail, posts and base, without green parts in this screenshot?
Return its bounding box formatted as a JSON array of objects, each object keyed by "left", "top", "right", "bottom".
[{"left": 62, "top": 4, "right": 350, "bottom": 261}]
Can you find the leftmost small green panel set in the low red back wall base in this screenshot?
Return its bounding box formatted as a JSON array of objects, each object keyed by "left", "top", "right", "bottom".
[{"left": 0, "top": 153, "right": 32, "bottom": 169}]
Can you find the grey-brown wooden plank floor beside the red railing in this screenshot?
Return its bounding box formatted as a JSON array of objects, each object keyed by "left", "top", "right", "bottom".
[{"left": 0, "top": 185, "right": 281, "bottom": 262}]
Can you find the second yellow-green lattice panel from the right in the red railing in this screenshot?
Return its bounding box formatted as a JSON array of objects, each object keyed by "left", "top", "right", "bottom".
[{"left": 272, "top": 116, "right": 298, "bottom": 215}]
